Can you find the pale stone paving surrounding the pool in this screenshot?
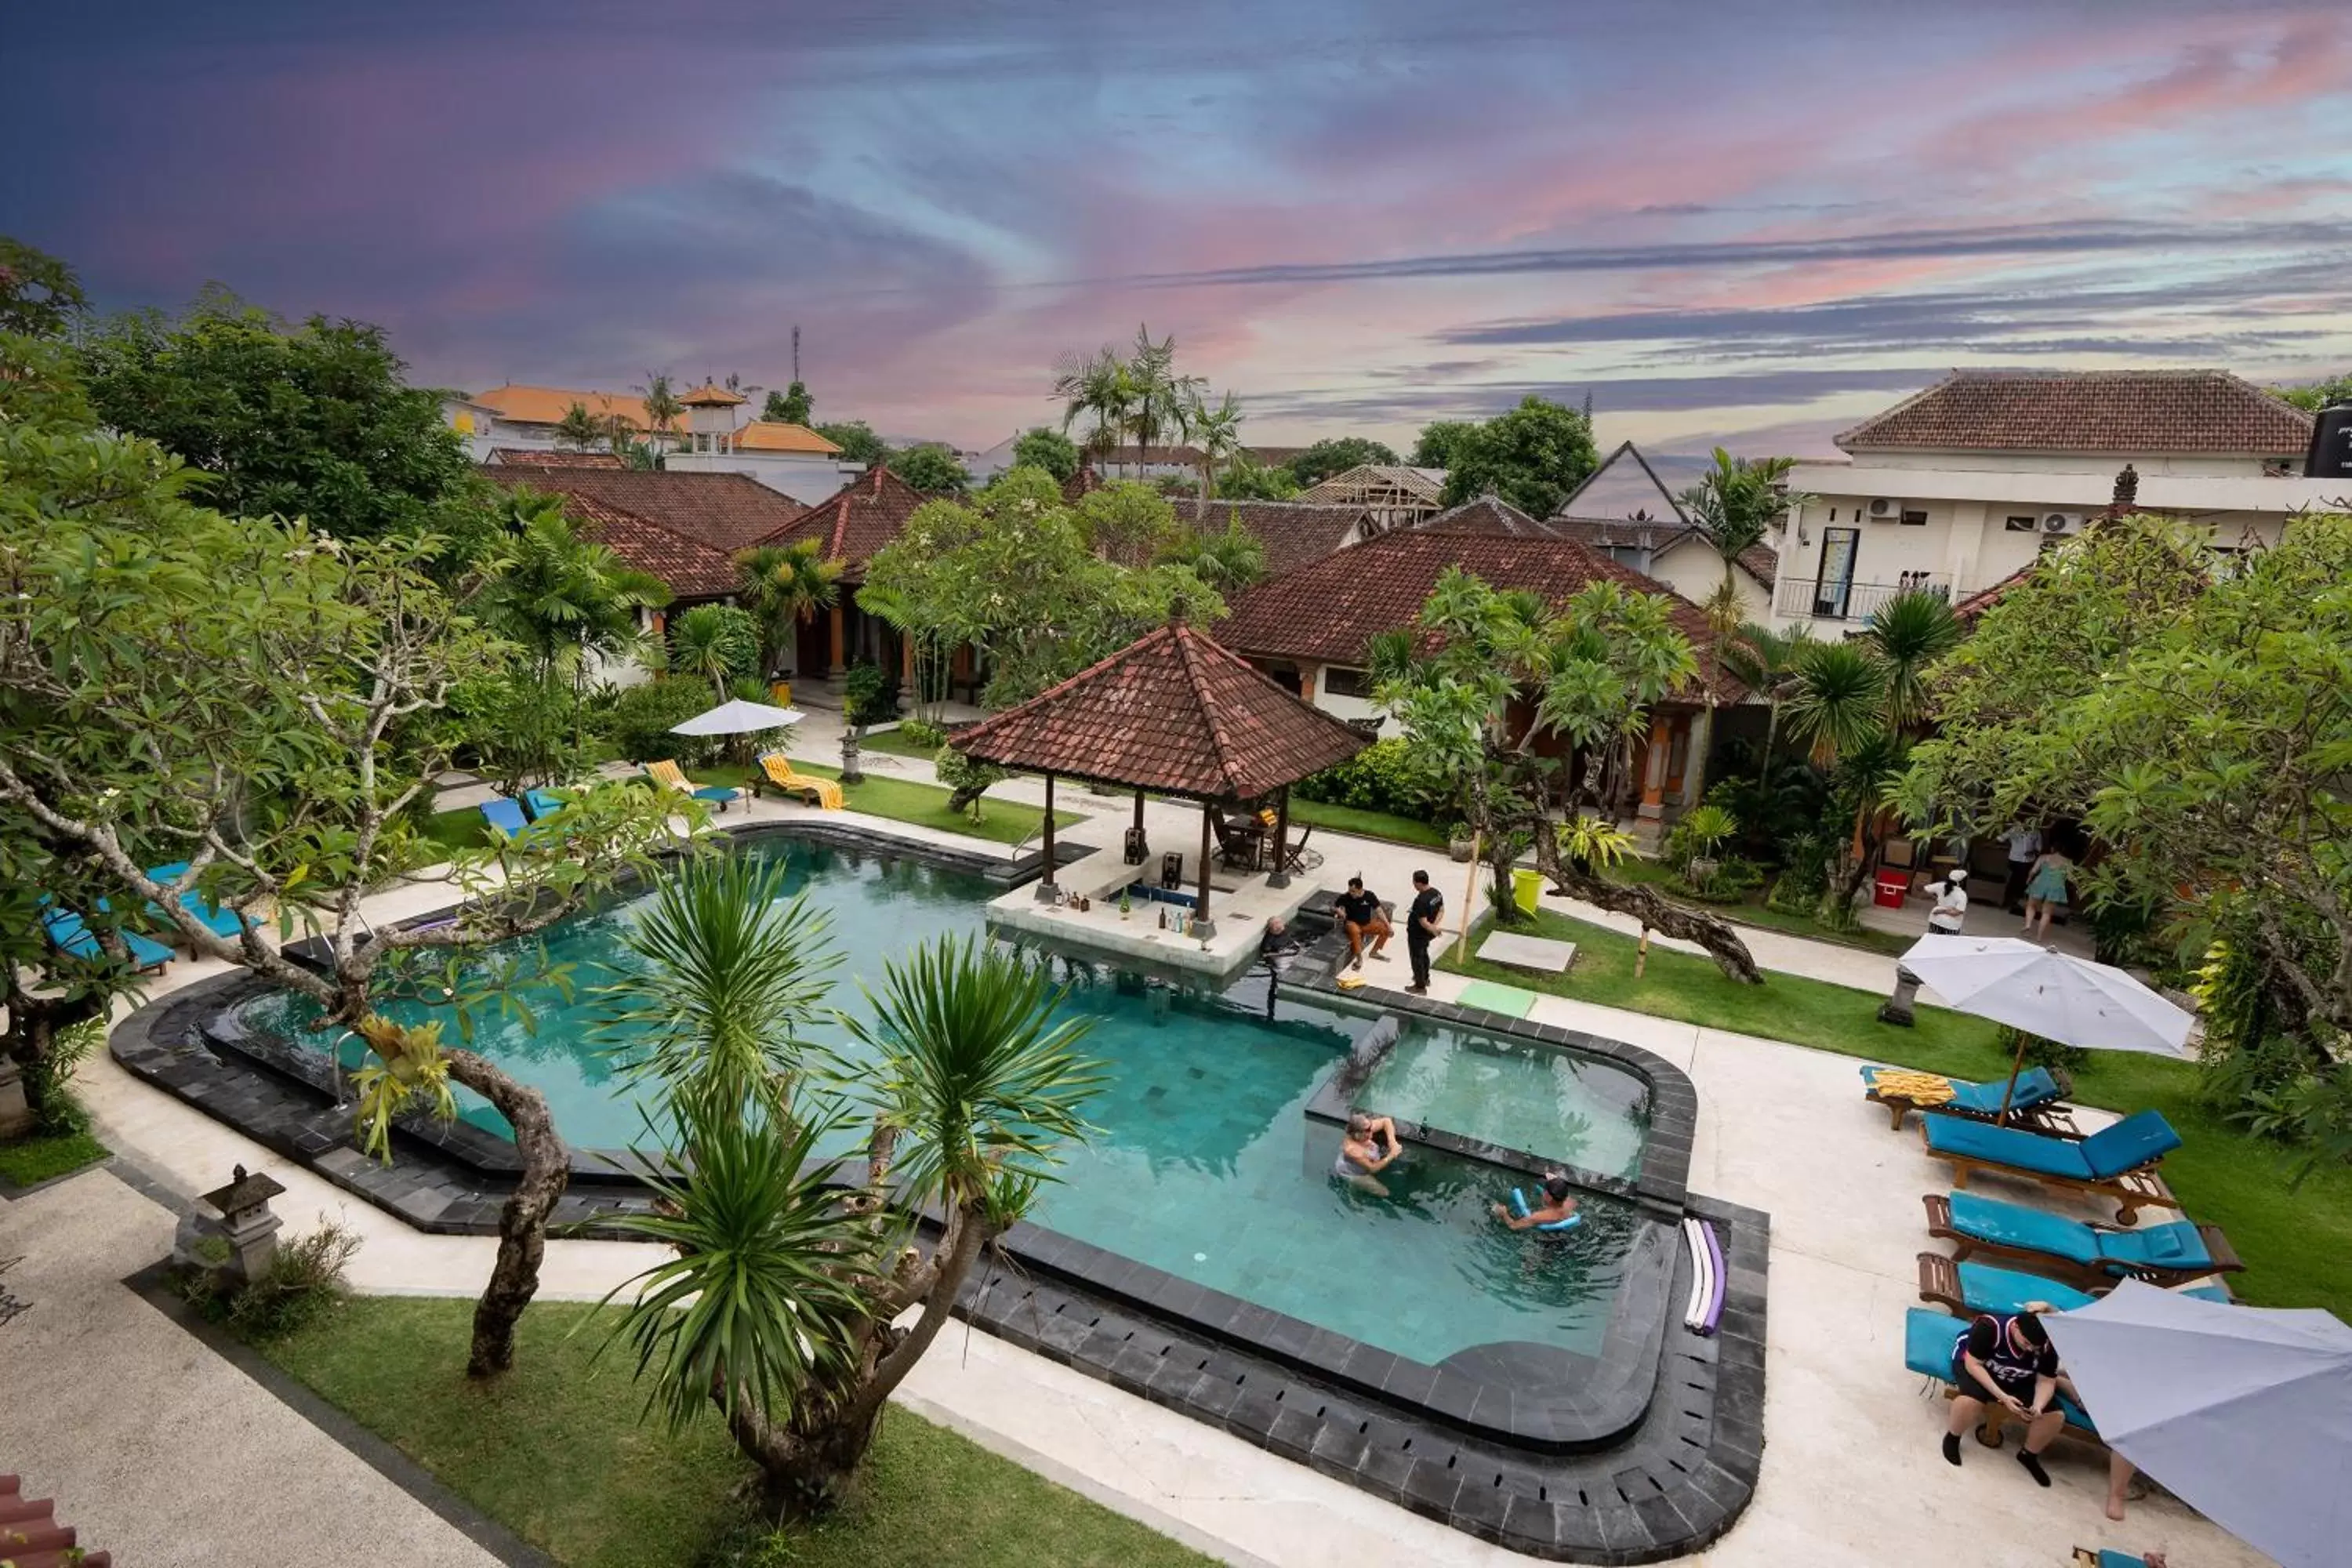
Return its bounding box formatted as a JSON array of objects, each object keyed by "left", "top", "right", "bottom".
[{"left": 0, "top": 785, "right": 2267, "bottom": 1568}]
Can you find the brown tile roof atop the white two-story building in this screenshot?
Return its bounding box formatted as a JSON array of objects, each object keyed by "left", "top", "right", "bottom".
[{"left": 1837, "top": 369, "right": 2312, "bottom": 459}]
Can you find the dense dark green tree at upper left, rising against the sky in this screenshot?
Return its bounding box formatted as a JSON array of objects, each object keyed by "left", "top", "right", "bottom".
[{"left": 80, "top": 289, "right": 492, "bottom": 553}]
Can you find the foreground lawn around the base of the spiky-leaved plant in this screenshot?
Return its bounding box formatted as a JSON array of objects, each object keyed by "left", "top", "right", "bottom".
[{"left": 259, "top": 1298, "right": 1209, "bottom": 1568}]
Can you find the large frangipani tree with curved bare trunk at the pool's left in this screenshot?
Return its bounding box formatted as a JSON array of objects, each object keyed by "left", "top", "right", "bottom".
[{"left": 0, "top": 343, "right": 691, "bottom": 1375}]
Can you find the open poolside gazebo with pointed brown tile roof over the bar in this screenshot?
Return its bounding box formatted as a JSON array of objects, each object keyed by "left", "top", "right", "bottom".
[{"left": 953, "top": 621, "right": 1369, "bottom": 935}]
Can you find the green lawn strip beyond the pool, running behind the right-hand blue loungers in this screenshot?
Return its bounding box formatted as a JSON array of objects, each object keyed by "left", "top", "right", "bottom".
[{"left": 1439, "top": 909, "right": 2352, "bottom": 1316}]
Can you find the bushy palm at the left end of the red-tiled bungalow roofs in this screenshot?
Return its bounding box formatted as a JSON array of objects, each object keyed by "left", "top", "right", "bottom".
[{"left": 475, "top": 489, "right": 670, "bottom": 687}]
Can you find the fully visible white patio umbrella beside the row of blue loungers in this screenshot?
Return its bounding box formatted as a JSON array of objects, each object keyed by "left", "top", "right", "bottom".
[{"left": 1903, "top": 933, "right": 2197, "bottom": 1114}]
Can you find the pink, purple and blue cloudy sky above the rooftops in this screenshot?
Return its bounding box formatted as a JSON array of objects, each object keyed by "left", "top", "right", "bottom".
[{"left": 0, "top": 0, "right": 2352, "bottom": 452}]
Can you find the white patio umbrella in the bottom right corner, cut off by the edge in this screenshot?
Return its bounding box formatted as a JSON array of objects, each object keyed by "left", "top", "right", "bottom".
[{"left": 2042, "top": 1279, "right": 2352, "bottom": 1568}]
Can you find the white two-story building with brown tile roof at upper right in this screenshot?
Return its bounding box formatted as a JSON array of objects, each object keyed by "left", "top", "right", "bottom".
[{"left": 1771, "top": 369, "right": 2347, "bottom": 637}]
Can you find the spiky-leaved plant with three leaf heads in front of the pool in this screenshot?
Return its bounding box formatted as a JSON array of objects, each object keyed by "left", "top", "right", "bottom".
[{"left": 593, "top": 865, "right": 1098, "bottom": 1516}]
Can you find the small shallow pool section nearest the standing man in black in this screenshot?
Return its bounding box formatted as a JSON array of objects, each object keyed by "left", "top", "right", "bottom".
[{"left": 1352, "top": 1020, "right": 1649, "bottom": 1180}]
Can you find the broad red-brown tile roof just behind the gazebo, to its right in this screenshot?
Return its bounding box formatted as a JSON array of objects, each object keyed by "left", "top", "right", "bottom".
[{"left": 1218, "top": 524, "right": 1748, "bottom": 703}]
